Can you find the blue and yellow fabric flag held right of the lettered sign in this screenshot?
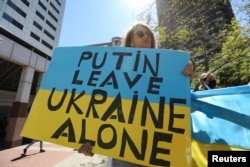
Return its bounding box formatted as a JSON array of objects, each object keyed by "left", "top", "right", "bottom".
[{"left": 191, "top": 85, "right": 250, "bottom": 167}]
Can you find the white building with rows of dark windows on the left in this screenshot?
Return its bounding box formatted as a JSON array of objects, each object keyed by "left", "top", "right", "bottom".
[{"left": 0, "top": 0, "right": 66, "bottom": 148}]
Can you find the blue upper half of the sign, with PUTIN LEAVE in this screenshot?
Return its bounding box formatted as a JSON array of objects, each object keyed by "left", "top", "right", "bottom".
[{"left": 41, "top": 46, "right": 190, "bottom": 105}]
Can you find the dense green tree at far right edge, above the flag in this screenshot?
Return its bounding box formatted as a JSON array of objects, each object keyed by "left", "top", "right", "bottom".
[{"left": 213, "top": 20, "right": 250, "bottom": 87}]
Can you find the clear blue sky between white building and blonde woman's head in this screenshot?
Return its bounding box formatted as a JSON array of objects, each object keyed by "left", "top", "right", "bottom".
[{"left": 59, "top": 0, "right": 154, "bottom": 47}]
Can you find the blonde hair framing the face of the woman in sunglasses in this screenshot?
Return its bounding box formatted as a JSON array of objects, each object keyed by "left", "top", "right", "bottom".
[{"left": 123, "top": 22, "right": 157, "bottom": 48}]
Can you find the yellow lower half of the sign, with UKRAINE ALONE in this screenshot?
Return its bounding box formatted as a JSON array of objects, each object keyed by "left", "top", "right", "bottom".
[{"left": 22, "top": 89, "right": 192, "bottom": 167}]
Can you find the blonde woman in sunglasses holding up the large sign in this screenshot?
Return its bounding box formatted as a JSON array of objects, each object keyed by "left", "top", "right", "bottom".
[{"left": 78, "top": 22, "right": 195, "bottom": 167}]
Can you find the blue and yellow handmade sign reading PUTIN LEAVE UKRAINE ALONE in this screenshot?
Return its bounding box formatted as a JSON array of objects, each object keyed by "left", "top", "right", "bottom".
[{"left": 21, "top": 46, "right": 191, "bottom": 167}]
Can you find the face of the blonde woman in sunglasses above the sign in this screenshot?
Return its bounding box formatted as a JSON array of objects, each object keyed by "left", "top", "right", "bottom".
[{"left": 131, "top": 26, "right": 152, "bottom": 48}]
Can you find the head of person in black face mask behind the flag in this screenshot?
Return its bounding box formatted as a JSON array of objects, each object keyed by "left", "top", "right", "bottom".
[{"left": 199, "top": 72, "right": 221, "bottom": 90}]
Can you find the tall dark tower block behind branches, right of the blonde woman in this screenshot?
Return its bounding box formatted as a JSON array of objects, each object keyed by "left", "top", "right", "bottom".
[{"left": 156, "top": 0, "right": 234, "bottom": 70}]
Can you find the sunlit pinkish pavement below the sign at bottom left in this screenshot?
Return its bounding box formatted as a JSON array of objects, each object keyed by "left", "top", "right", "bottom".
[{"left": 0, "top": 142, "right": 109, "bottom": 167}]
